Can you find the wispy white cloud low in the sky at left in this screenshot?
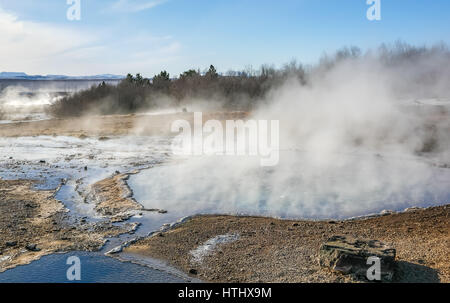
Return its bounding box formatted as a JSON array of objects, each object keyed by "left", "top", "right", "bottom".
[{"left": 0, "top": 7, "right": 182, "bottom": 75}]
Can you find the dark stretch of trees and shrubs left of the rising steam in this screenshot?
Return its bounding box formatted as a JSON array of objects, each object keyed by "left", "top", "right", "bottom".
[{"left": 50, "top": 62, "right": 305, "bottom": 117}]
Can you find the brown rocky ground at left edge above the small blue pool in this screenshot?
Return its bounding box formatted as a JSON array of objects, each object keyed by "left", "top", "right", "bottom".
[{"left": 0, "top": 179, "right": 136, "bottom": 272}]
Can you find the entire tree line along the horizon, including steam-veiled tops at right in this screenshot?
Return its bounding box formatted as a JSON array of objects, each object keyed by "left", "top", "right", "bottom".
[{"left": 49, "top": 42, "right": 450, "bottom": 117}]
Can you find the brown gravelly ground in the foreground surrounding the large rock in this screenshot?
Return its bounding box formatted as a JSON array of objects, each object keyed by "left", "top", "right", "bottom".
[{"left": 124, "top": 205, "right": 450, "bottom": 283}]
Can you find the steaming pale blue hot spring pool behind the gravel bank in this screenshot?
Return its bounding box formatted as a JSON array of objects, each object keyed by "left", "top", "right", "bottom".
[{"left": 129, "top": 151, "right": 450, "bottom": 219}]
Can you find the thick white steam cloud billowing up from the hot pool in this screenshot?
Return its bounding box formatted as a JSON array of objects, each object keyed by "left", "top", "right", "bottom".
[{"left": 131, "top": 46, "right": 450, "bottom": 218}]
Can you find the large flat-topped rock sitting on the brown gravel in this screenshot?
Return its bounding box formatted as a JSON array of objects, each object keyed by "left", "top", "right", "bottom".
[{"left": 319, "top": 236, "right": 396, "bottom": 281}]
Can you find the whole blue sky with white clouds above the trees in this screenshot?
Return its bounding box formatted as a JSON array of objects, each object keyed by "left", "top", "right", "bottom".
[{"left": 0, "top": 0, "right": 450, "bottom": 77}]
